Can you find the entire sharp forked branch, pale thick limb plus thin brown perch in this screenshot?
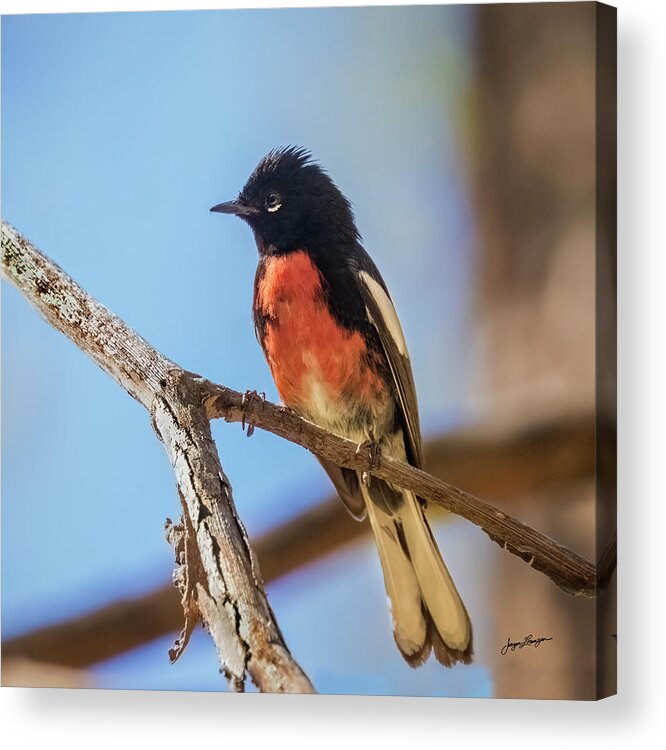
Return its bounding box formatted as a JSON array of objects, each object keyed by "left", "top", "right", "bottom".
[{"left": 2, "top": 224, "right": 615, "bottom": 676}]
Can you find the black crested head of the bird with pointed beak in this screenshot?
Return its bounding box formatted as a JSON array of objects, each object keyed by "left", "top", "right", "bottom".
[{"left": 211, "top": 146, "right": 359, "bottom": 253}]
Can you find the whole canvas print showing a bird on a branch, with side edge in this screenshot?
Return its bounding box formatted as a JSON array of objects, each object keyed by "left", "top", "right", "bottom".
[{"left": 2, "top": 3, "right": 617, "bottom": 700}]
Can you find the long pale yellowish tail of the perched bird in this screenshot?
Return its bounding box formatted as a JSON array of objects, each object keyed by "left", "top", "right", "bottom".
[{"left": 361, "top": 478, "right": 472, "bottom": 667}]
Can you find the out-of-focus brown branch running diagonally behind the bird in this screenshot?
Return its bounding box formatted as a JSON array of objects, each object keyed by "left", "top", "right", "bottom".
[{"left": 3, "top": 413, "right": 595, "bottom": 668}]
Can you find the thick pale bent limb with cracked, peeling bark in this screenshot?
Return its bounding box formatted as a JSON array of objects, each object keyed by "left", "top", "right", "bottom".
[{"left": 2, "top": 222, "right": 314, "bottom": 693}]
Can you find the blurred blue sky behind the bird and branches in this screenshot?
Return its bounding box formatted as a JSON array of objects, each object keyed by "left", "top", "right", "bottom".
[{"left": 2, "top": 7, "right": 490, "bottom": 695}]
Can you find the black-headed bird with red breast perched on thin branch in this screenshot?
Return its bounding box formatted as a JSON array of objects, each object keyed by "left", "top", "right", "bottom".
[{"left": 210, "top": 146, "right": 473, "bottom": 667}]
